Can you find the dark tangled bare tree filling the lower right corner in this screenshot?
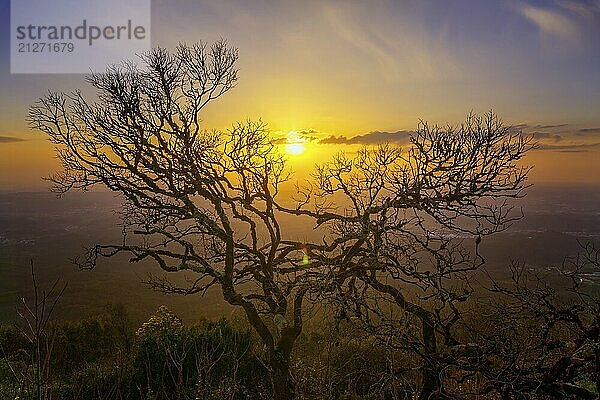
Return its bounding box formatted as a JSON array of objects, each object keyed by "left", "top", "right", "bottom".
[{"left": 461, "top": 243, "right": 600, "bottom": 399}]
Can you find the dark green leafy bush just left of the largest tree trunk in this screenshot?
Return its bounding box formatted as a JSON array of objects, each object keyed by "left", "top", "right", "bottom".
[{"left": 135, "top": 306, "right": 267, "bottom": 399}]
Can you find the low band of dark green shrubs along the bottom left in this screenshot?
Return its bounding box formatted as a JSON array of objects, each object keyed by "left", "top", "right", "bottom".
[{"left": 0, "top": 306, "right": 269, "bottom": 400}]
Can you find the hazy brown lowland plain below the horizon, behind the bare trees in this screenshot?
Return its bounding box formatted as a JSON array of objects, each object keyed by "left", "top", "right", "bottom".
[{"left": 0, "top": 184, "right": 600, "bottom": 322}]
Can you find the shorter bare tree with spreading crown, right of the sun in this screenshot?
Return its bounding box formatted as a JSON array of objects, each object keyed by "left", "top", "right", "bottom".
[{"left": 283, "top": 112, "right": 533, "bottom": 399}]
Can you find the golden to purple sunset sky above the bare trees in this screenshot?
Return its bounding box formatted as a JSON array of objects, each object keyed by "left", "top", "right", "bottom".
[{"left": 0, "top": 0, "right": 600, "bottom": 190}]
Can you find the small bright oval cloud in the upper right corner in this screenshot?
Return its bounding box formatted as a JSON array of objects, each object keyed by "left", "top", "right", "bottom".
[{"left": 519, "top": 4, "right": 579, "bottom": 40}]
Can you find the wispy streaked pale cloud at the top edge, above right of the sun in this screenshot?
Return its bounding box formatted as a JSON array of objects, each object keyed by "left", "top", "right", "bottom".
[{"left": 319, "top": 0, "right": 465, "bottom": 83}]
